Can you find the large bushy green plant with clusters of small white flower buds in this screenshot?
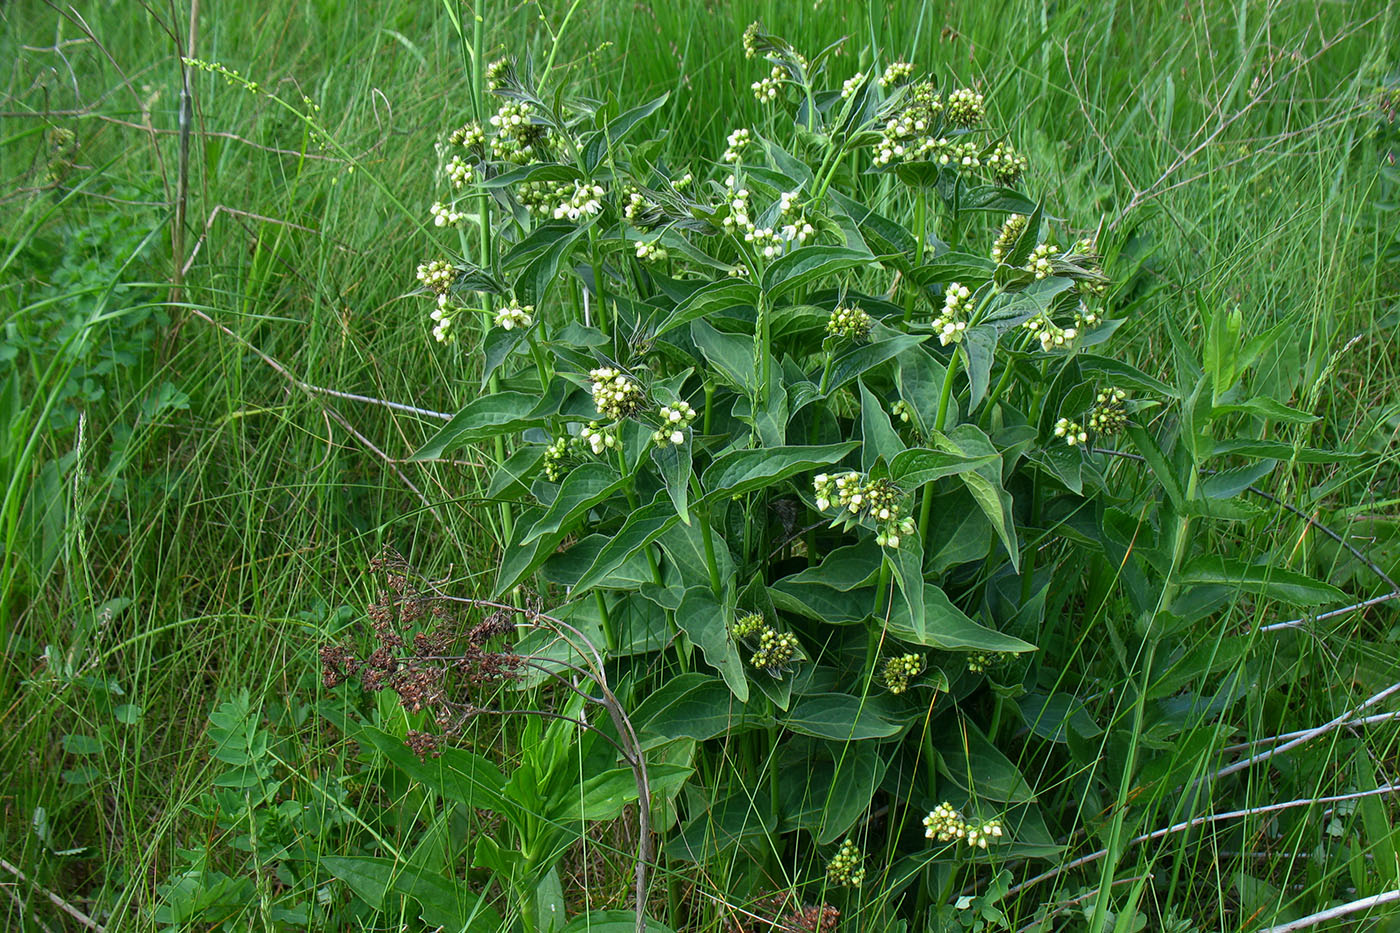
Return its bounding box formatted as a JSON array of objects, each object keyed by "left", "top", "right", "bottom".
[{"left": 355, "top": 24, "right": 1360, "bottom": 925}]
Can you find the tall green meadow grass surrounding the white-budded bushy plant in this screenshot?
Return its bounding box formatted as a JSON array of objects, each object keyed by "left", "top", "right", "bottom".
[{"left": 0, "top": 0, "right": 1400, "bottom": 929}]
